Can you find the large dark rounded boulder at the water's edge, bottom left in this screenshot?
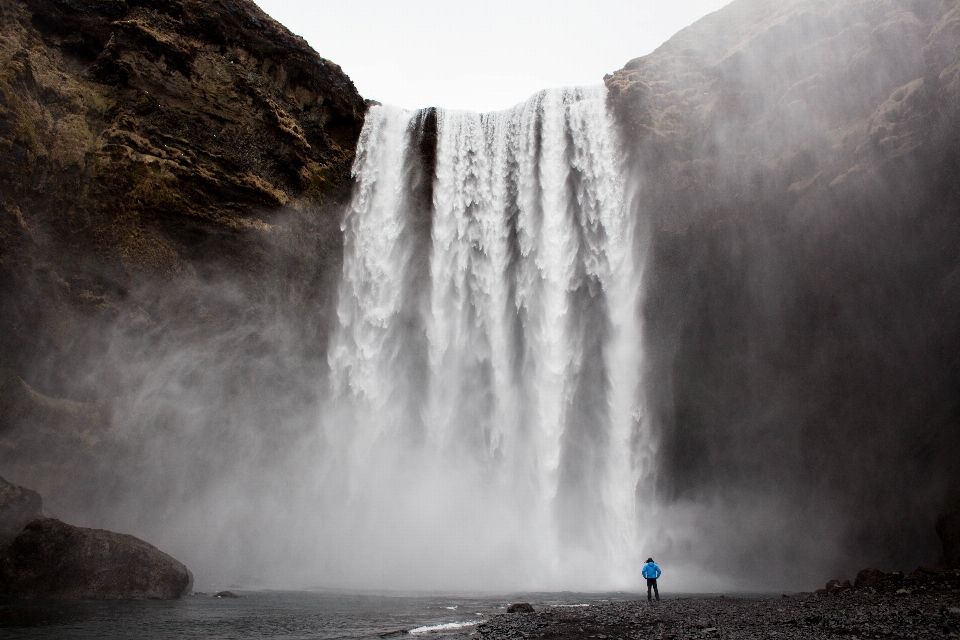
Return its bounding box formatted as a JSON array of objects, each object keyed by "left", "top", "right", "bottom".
[{"left": 0, "top": 518, "right": 190, "bottom": 600}]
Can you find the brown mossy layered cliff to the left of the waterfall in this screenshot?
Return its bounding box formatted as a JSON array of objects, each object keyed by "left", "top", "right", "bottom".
[{"left": 0, "top": 0, "right": 366, "bottom": 500}]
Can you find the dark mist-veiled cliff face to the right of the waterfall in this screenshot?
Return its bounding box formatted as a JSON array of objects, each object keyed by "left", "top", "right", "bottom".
[{"left": 606, "top": 0, "right": 960, "bottom": 584}]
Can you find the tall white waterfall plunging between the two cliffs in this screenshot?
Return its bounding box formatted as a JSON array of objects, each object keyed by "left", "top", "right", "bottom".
[{"left": 322, "top": 87, "right": 644, "bottom": 589}]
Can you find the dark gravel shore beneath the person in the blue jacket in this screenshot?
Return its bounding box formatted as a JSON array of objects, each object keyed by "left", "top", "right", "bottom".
[{"left": 471, "top": 573, "right": 960, "bottom": 640}]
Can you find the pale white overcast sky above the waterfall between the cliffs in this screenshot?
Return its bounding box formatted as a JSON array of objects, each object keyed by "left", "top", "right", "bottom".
[{"left": 251, "top": 0, "right": 729, "bottom": 111}]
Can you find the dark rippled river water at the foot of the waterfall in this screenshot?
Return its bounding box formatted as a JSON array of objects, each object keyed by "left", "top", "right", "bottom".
[{"left": 0, "top": 591, "right": 638, "bottom": 640}]
